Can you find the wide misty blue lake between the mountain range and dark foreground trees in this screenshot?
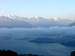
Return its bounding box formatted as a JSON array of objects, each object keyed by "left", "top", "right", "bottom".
[{"left": 0, "top": 27, "right": 75, "bottom": 56}]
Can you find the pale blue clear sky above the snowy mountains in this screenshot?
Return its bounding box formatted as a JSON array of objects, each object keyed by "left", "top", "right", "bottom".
[{"left": 0, "top": 0, "right": 75, "bottom": 17}]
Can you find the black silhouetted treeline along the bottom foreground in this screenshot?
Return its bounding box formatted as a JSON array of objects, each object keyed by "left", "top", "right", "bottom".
[{"left": 0, "top": 50, "right": 75, "bottom": 56}]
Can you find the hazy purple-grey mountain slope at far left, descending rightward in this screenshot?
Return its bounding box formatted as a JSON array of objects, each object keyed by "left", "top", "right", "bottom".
[{"left": 0, "top": 16, "right": 31, "bottom": 27}]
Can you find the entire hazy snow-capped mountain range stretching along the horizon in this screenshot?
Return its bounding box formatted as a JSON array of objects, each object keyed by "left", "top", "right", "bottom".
[{"left": 0, "top": 16, "right": 74, "bottom": 27}]
